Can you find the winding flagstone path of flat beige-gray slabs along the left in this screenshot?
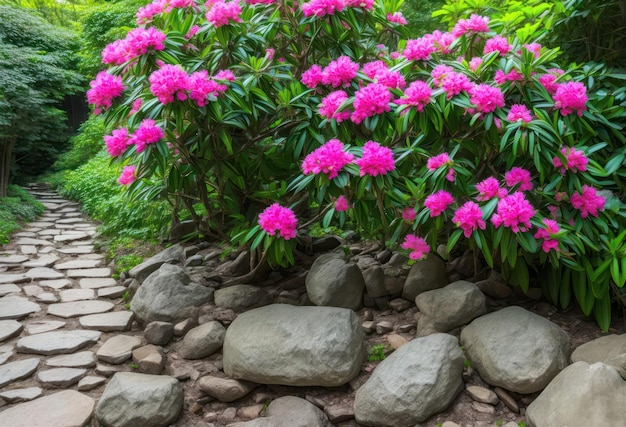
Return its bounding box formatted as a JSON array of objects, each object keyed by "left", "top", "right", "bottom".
[{"left": 0, "top": 189, "right": 136, "bottom": 427}]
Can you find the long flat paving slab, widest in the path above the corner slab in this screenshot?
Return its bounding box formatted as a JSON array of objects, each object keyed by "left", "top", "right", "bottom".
[{"left": 17, "top": 330, "right": 102, "bottom": 355}]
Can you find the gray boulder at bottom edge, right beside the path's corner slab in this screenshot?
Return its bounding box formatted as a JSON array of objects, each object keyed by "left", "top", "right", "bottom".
[{"left": 96, "top": 372, "right": 184, "bottom": 427}]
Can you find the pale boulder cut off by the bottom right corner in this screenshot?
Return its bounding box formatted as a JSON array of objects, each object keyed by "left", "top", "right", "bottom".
[{"left": 526, "top": 362, "right": 626, "bottom": 427}]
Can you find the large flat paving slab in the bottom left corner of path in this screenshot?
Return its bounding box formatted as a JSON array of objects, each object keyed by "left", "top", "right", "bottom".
[{"left": 2, "top": 390, "right": 96, "bottom": 427}]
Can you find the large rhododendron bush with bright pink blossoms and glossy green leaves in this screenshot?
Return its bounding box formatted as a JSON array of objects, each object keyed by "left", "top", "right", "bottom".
[{"left": 88, "top": 0, "right": 626, "bottom": 329}]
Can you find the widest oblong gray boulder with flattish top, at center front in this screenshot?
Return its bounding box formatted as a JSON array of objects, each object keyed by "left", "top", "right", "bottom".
[{"left": 222, "top": 304, "right": 365, "bottom": 387}]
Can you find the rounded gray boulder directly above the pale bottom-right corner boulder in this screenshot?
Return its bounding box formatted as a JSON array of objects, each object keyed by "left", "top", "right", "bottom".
[{"left": 461, "top": 307, "right": 570, "bottom": 394}]
